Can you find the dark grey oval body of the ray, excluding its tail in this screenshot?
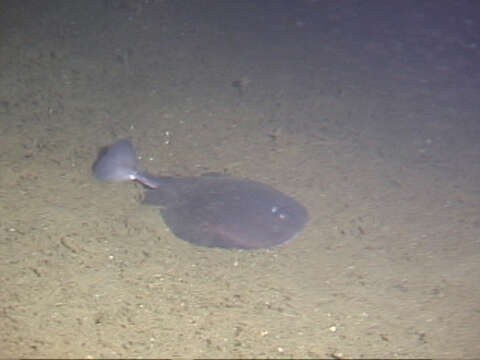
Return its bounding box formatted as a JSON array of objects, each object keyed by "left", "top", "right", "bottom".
[{"left": 144, "top": 176, "right": 308, "bottom": 249}]
